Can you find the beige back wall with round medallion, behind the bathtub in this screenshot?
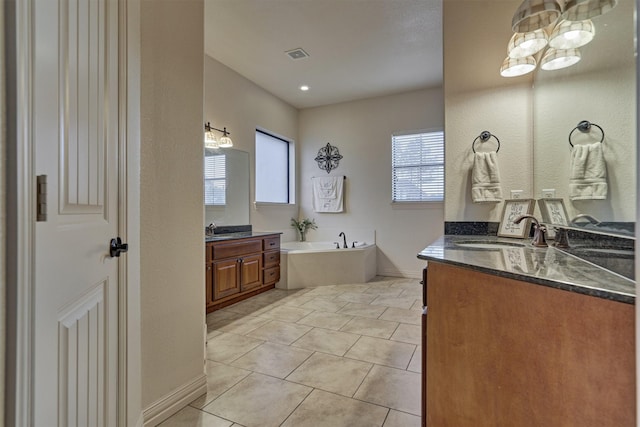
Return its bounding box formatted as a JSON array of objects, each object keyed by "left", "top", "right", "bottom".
[{"left": 299, "top": 89, "right": 444, "bottom": 277}]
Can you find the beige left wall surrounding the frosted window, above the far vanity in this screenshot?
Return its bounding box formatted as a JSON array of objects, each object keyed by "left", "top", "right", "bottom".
[{"left": 201, "top": 55, "right": 300, "bottom": 239}]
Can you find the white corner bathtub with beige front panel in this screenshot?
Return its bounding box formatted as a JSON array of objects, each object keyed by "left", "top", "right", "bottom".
[{"left": 276, "top": 242, "right": 377, "bottom": 289}]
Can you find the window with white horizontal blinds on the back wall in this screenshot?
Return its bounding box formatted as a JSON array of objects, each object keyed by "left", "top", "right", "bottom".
[{"left": 391, "top": 131, "right": 444, "bottom": 202}]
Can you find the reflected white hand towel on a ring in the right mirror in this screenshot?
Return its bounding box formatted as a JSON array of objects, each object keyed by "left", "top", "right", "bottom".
[{"left": 569, "top": 142, "right": 607, "bottom": 200}]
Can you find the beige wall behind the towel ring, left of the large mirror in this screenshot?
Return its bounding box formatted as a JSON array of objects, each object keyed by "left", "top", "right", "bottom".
[{"left": 443, "top": 0, "right": 534, "bottom": 222}]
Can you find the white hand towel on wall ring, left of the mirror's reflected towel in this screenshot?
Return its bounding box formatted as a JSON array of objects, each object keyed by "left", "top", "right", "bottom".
[{"left": 471, "top": 151, "right": 502, "bottom": 203}]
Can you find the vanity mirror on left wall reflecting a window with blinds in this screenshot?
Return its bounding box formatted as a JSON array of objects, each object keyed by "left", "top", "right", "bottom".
[{"left": 204, "top": 148, "right": 250, "bottom": 225}]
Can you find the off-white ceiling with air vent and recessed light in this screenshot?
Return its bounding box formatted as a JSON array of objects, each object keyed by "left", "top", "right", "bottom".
[{"left": 205, "top": 0, "right": 442, "bottom": 108}]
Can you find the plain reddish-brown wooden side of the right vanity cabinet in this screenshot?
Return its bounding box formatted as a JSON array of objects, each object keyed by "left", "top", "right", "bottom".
[{"left": 423, "top": 261, "right": 636, "bottom": 427}]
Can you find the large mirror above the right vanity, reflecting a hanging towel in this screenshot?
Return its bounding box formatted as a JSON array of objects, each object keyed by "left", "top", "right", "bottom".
[{"left": 533, "top": 1, "right": 637, "bottom": 237}]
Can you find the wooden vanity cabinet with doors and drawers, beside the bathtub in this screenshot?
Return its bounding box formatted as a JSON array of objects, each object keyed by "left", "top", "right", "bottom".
[{"left": 206, "top": 235, "right": 280, "bottom": 313}]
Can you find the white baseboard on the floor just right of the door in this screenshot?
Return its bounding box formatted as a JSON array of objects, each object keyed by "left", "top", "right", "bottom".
[{"left": 142, "top": 374, "right": 207, "bottom": 427}]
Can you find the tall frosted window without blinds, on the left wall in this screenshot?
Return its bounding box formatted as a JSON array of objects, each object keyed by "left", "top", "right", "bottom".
[{"left": 256, "top": 130, "right": 293, "bottom": 203}]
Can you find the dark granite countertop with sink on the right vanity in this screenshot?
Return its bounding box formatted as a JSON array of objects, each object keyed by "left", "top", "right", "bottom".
[{"left": 418, "top": 235, "right": 636, "bottom": 304}]
